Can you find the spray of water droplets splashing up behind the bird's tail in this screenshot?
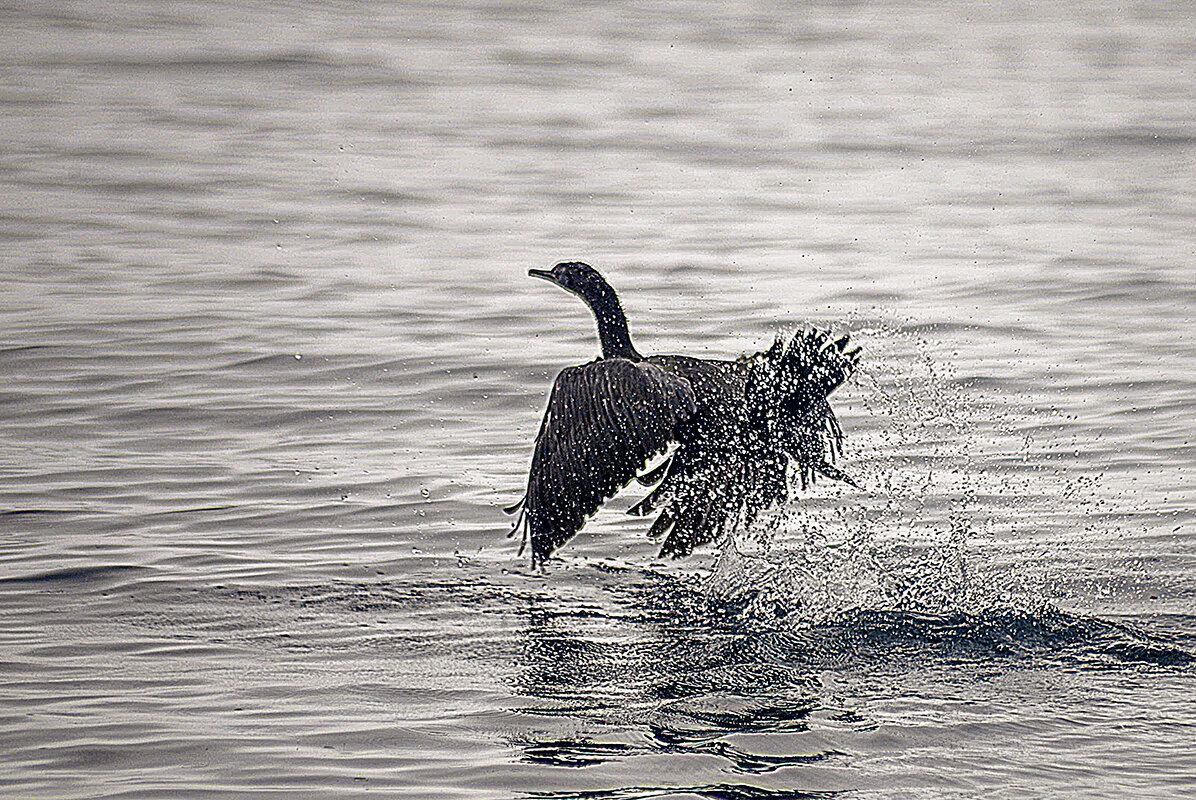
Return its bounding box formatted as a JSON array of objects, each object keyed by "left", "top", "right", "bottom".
[{"left": 706, "top": 324, "right": 1081, "bottom": 627}]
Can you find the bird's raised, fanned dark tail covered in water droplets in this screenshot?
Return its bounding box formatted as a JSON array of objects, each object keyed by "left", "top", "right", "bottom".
[{"left": 744, "top": 329, "right": 860, "bottom": 489}]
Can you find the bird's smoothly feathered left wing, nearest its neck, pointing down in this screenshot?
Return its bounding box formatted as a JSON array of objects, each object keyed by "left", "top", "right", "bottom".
[{"left": 511, "top": 359, "right": 697, "bottom": 566}]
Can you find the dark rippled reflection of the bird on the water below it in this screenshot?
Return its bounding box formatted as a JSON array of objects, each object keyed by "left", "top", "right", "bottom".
[{"left": 514, "top": 564, "right": 842, "bottom": 798}]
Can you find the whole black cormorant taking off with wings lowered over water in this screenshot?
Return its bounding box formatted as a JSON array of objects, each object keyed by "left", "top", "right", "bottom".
[{"left": 505, "top": 261, "right": 859, "bottom": 567}]
